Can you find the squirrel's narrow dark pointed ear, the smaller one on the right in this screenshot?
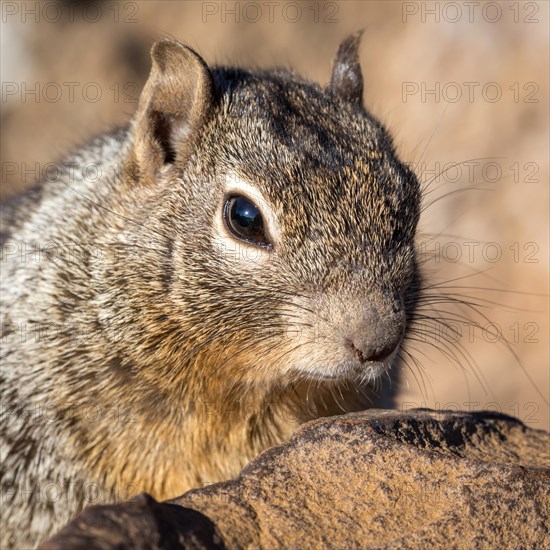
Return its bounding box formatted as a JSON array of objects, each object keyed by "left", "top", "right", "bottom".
[{"left": 329, "top": 30, "right": 363, "bottom": 105}]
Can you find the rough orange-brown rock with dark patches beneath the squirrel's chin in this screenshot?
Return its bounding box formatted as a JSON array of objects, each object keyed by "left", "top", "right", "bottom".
[{"left": 41, "top": 410, "right": 550, "bottom": 550}]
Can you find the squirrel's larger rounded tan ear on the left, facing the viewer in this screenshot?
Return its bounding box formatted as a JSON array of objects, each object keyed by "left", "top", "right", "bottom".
[{"left": 133, "top": 40, "right": 214, "bottom": 185}]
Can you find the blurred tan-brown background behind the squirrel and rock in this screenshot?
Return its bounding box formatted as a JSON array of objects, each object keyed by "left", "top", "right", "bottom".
[{"left": 0, "top": 1, "right": 550, "bottom": 428}]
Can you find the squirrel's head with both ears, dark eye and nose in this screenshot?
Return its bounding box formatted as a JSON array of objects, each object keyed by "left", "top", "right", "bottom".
[{"left": 121, "top": 33, "right": 420, "bottom": 394}]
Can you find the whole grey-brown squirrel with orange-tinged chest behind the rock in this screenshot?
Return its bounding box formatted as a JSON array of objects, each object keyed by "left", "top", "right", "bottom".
[{"left": 1, "top": 33, "right": 421, "bottom": 548}]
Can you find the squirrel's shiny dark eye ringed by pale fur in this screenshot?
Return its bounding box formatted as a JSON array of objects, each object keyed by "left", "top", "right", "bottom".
[{"left": 223, "top": 195, "right": 270, "bottom": 246}]
